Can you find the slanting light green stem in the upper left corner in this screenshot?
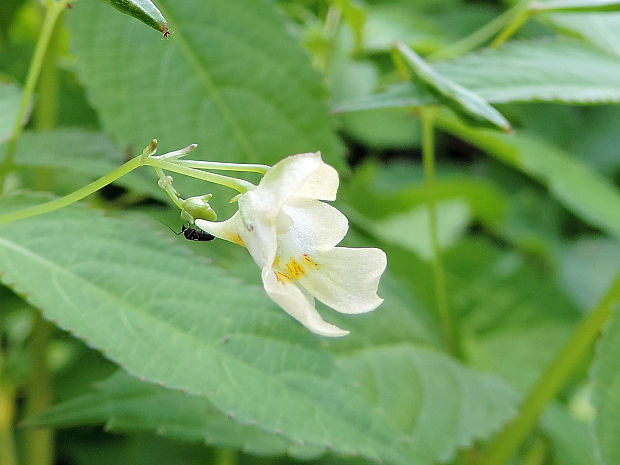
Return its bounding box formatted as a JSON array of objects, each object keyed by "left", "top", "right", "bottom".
[{"left": 0, "top": 0, "right": 69, "bottom": 192}]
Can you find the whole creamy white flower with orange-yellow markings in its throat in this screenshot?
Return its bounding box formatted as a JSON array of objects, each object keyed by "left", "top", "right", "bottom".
[{"left": 196, "top": 152, "right": 387, "bottom": 336}]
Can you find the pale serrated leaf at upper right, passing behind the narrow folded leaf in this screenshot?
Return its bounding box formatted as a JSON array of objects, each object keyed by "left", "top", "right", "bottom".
[{"left": 332, "top": 38, "right": 620, "bottom": 113}]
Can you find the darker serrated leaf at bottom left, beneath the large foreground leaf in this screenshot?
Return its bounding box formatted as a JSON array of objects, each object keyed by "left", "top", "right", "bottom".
[{"left": 25, "top": 371, "right": 322, "bottom": 459}]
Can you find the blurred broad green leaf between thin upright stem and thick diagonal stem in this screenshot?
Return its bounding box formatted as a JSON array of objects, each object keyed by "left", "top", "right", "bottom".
[{"left": 432, "top": 239, "right": 582, "bottom": 393}]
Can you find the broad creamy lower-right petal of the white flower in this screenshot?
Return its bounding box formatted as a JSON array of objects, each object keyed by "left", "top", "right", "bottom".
[{"left": 298, "top": 247, "right": 387, "bottom": 313}]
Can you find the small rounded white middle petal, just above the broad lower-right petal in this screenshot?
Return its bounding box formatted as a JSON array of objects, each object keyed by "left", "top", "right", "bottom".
[{"left": 278, "top": 199, "right": 349, "bottom": 252}]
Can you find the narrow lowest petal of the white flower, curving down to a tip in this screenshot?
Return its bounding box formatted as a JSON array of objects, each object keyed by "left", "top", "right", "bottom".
[{"left": 262, "top": 266, "right": 349, "bottom": 337}]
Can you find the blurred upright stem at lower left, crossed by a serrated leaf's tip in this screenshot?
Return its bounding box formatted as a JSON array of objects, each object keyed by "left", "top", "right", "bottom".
[{"left": 24, "top": 312, "right": 54, "bottom": 465}]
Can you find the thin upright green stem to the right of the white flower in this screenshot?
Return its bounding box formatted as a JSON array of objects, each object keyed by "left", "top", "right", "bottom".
[{"left": 420, "top": 107, "right": 457, "bottom": 354}]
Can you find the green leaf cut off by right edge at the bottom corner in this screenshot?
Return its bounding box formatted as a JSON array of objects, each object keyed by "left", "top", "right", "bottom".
[{"left": 592, "top": 306, "right": 620, "bottom": 465}]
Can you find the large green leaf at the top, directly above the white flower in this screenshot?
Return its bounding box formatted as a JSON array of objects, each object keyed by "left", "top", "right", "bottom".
[{"left": 70, "top": 0, "right": 342, "bottom": 166}]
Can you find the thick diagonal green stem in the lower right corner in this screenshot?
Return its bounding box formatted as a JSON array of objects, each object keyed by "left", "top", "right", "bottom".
[{"left": 482, "top": 273, "right": 620, "bottom": 465}]
